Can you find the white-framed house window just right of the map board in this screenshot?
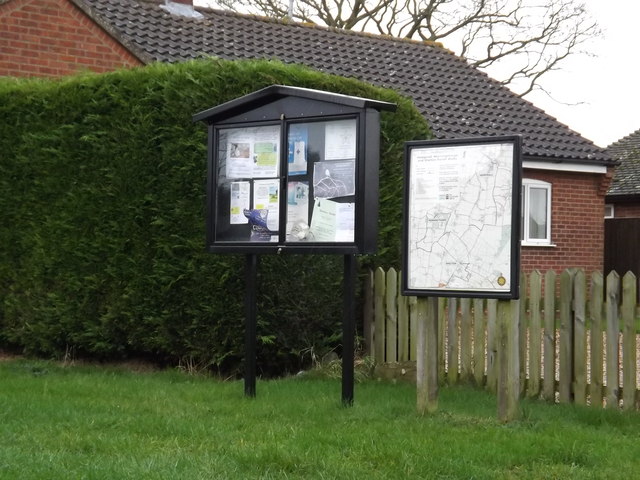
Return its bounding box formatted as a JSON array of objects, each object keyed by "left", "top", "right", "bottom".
[{"left": 521, "top": 178, "right": 551, "bottom": 245}]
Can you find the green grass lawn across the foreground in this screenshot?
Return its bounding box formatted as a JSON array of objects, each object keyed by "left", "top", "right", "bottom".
[{"left": 0, "top": 360, "right": 640, "bottom": 480}]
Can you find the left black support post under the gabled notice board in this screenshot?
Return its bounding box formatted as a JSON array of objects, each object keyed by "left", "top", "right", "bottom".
[{"left": 244, "top": 253, "right": 258, "bottom": 397}]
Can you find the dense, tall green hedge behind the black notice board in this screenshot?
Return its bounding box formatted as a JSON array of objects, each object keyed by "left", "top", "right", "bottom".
[{"left": 0, "top": 60, "right": 428, "bottom": 374}]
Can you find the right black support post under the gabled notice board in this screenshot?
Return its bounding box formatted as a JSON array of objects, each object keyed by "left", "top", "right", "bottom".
[{"left": 342, "top": 255, "right": 356, "bottom": 406}]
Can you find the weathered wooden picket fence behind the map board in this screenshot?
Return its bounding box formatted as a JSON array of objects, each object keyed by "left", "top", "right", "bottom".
[{"left": 363, "top": 268, "right": 640, "bottom": 410}]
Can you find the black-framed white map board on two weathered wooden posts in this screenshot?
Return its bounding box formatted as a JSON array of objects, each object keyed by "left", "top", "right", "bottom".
[{"left": 401, "top": 136, "right": 524, "bottom": 421}]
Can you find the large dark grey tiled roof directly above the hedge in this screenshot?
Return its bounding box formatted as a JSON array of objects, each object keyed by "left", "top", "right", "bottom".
[{"left": 72, "top": 0, "right": 609, "bottom": 163}]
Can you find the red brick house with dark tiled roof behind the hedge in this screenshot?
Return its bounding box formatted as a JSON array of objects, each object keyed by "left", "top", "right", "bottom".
[{"left": 0, "top": 0, "right": 614, "bottom": 271}]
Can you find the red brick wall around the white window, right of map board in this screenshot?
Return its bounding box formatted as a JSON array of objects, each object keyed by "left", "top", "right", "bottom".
[{"left": 521, "top": 170, "right": 609, "bottom": 273}]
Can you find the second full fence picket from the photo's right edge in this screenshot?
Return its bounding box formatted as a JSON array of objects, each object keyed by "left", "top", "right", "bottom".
[{"left": 605, "top": 271, "right": 620, "bottom": 408}]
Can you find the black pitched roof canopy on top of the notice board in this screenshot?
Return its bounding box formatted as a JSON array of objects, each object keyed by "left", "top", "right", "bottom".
[{"left": 193, "top": 85, "right": 397, "bottom": 123}]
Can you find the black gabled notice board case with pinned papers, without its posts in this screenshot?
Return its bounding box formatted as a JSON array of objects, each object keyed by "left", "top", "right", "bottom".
[{"left": 194, "top": 85, "right": 395, "bottom": 254}]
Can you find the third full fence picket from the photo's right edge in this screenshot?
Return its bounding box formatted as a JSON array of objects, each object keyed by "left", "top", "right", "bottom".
[{"left": 589, "top": 272, "right": 604, "bottom": 408}]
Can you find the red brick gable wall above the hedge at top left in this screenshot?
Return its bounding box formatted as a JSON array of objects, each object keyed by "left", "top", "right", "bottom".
[{"left": 0, "top": 0, "right": 142, "bottom": 77}]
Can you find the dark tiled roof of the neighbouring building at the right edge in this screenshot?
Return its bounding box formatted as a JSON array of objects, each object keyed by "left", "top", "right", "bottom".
[{"left": 606, "top": 130, "right": 640, "bottom": 195}]
